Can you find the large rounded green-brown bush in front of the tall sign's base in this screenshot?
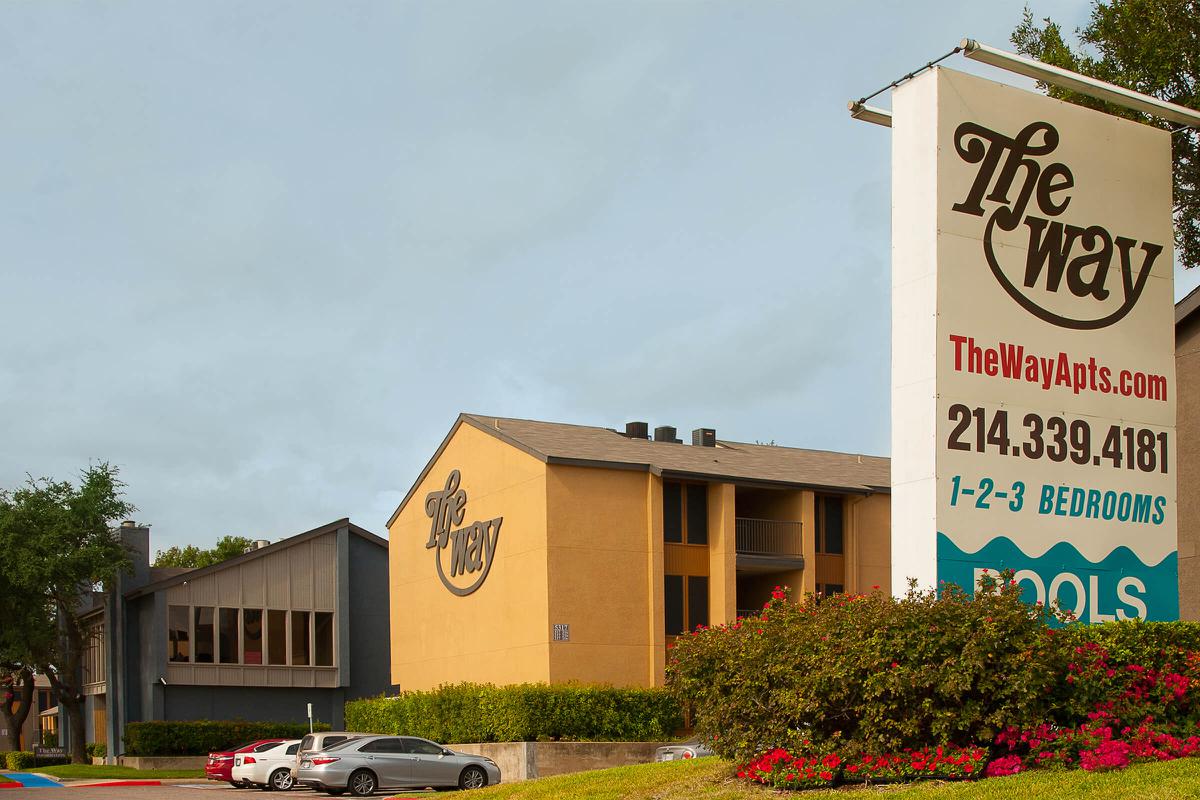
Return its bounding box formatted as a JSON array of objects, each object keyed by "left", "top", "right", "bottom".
[{"left": 667, "top": 582, "right": 1061, "bottom": 763}]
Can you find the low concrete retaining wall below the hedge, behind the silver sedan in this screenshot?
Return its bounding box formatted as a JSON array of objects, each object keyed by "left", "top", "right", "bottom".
[{"left": 450, "top": 741, "right": 667, "bottom": 783}]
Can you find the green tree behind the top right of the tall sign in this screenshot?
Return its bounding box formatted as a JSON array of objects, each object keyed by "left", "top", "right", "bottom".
[{"left": 1012, "top": 0, "right": 1200, "bottom": 267}]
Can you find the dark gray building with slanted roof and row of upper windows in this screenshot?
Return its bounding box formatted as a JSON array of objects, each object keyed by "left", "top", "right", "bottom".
[{"left": 75, "top": 519, "right": 390, "bottom": 754}]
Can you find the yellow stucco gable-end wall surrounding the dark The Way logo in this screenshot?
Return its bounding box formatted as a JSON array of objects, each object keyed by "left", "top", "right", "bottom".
[{"left": 388, "top": 423, "right": 551, "bottom": 690}]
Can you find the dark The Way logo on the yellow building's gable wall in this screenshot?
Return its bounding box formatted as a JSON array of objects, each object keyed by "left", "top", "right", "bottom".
[{"left": 425, "top": 470, "right": 504, "bottom": 597}]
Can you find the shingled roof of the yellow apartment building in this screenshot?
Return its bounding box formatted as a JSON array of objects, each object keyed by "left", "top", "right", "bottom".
[{"left": 388, "top": 414, "right": 892, "bottom": 525}]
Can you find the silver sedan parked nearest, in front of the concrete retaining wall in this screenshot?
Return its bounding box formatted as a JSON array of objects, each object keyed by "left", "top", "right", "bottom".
[{"left": 296, "top": 736, "right": 500, "bottom": 798}]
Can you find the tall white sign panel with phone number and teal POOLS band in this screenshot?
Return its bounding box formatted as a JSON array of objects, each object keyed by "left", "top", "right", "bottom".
[{"left": 892, "top": 68, "right": 1178, "bottom": 622}]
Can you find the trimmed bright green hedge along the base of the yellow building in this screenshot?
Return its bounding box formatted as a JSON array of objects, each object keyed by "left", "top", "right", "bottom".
[{"left": 346, "top": 684, "right": 683, "bottom": 744}]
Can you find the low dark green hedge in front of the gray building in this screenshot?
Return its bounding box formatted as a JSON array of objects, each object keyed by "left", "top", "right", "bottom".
[{"left": 125, "top": 720, "right": 329, "bottom": 756}]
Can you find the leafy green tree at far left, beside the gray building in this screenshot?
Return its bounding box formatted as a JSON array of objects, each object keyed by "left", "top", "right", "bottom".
[{"left": 0, "top": 463, "right": 134, "bottom": 764}]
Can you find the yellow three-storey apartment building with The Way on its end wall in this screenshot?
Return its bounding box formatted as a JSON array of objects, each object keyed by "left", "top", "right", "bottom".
[{"left": 388, "top": 414, "right": 890, "bottom": 690}]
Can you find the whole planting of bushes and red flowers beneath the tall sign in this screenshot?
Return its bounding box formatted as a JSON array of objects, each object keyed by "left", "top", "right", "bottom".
[{"left": 681, "top": 576, "right": 1200, "bottom": 788}]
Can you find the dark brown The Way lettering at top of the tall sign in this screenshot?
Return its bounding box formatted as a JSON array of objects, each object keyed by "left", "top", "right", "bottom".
[{"left": 952, "top": 121, "right": 1163, "bottom": 330}]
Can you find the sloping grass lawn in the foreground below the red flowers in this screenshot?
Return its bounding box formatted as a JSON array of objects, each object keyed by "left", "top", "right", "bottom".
[{"left": 456, "top": 758, "right": 1200, "bottom": 800}]
